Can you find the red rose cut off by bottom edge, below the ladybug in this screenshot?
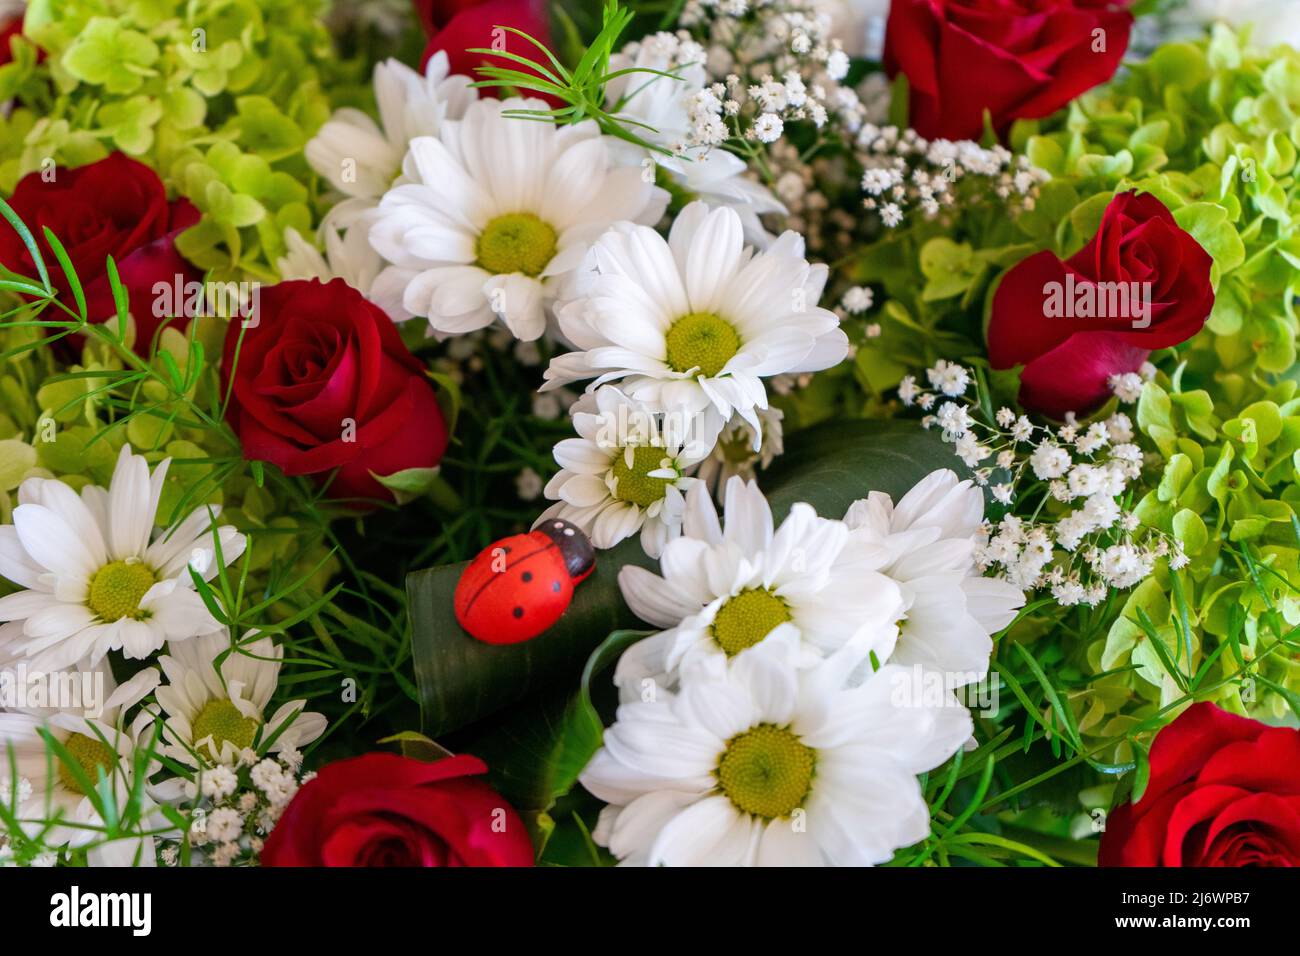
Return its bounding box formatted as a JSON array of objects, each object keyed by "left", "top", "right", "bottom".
[{"left": 261, "top": 753, "right": 533, "bottom": 866}]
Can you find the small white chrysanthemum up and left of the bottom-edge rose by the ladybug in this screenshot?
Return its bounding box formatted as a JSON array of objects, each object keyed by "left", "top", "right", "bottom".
[{"left": 155, "top": 631, "right": 325, "bottom": 766}]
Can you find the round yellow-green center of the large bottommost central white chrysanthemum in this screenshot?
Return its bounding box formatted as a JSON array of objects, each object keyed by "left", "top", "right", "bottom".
[{"left": 716, "top": 723, "right": 816, "bottom": 819}]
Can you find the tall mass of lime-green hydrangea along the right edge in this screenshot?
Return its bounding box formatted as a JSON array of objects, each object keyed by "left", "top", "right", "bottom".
[{"left": 1013, "top": 26, "right": 1300, "bottom": 733}]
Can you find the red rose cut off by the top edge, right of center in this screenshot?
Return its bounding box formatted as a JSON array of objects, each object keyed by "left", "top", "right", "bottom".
[{"left": 884, "top": 0, "right": 1134, "bottom": 139}]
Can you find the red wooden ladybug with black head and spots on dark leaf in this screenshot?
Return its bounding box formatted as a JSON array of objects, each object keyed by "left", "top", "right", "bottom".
[{"left": 455, "top": 518, "right": 595, "bottom": 644}]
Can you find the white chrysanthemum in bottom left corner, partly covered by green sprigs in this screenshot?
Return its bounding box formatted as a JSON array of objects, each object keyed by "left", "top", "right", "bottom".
[{"left": 0, "top": 665, "right": 165, "bottom": 866}]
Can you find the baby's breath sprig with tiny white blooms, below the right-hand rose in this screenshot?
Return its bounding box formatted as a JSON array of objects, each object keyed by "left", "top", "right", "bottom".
[{"left": 898, "top": 360, "right": 1187, "bottom": 607}]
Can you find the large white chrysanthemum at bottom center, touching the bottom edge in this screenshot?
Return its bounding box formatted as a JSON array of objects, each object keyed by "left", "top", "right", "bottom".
[{"left": 580, "top": 633, "right": 971, "bottom": 866}]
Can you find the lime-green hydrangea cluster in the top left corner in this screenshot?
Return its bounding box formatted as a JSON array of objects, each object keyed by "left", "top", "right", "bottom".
[{"left": 0, "top": 0, "right": 364, "bottom": 281}]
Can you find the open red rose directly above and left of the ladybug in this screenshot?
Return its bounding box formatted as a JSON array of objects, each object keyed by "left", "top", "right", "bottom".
[{"left": 221, "top": 278, "right": 447, "bottom": 499}]
